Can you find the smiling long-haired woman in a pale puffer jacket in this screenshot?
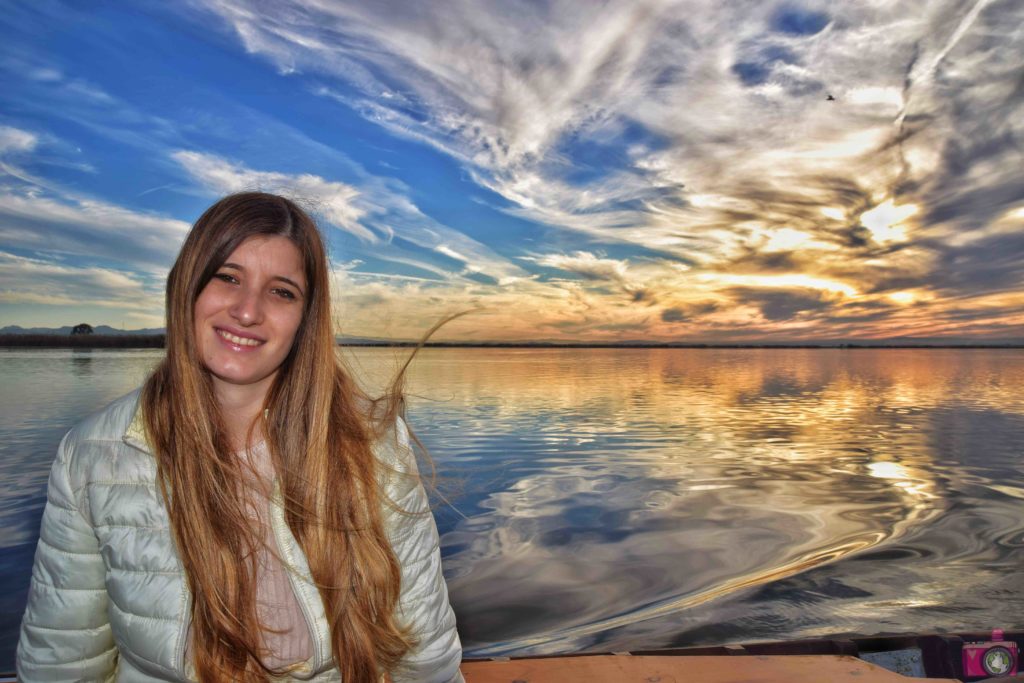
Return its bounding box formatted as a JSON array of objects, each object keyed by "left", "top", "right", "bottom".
[{"left": 17, "top": 193, "right": 462, "bottom": 683}]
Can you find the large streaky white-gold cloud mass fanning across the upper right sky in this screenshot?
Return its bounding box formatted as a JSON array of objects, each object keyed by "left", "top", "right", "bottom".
[{"left": 193, "top": 0, "right": 1024, "bottom": 331}]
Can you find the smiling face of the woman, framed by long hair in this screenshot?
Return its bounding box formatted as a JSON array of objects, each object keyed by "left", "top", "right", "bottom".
[{"left": 194, "top": 236, "right": 306, "bottom": 394}]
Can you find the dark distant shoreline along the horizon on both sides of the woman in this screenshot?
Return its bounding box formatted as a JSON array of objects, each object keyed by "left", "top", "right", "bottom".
[{"left": 0, "top": 335, "right": 1024, "bottom": 349}]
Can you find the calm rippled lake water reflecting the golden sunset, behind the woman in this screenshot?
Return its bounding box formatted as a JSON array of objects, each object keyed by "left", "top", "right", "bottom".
[{"left": 0, "top": 349, "right": 1024, "bottom": 669}]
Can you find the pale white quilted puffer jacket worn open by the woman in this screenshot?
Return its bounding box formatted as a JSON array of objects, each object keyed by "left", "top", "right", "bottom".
[{"left": 17, "top": 390, "right": 463, "bottom": 683}]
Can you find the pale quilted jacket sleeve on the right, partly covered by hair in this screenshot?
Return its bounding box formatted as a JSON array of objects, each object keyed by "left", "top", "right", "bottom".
[{"left": 385, "top": 419, "right": 464, "bottom": 683}]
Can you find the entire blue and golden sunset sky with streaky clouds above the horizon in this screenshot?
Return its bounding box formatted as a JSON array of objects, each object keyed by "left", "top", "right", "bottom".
[{"left": 0, "top": 0, "right": 1024, "bottom": 343}]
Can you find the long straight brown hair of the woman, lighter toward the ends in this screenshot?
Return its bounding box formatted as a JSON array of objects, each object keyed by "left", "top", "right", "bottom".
[{"left": 142, "top": 193, "right": 413, "bottom": 683}]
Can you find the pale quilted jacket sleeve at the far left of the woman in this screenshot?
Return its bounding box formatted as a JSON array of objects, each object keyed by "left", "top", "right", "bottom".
[{"left": 17, "top": 436, "right": 117, "bottom": 681}]
